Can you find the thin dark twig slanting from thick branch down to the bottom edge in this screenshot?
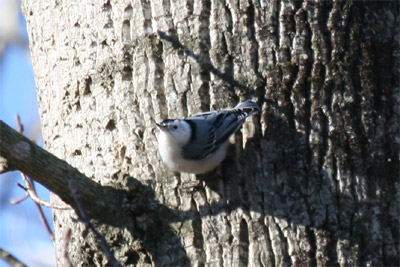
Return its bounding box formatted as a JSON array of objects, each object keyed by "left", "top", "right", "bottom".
[{"left": 68, "top": 180, "right": 121, "bottom": 266}]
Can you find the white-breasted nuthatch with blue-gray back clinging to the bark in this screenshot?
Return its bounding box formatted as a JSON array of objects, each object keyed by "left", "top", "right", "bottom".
[{"left": 157, "top": 100, "right": 259, "bottom": 174}]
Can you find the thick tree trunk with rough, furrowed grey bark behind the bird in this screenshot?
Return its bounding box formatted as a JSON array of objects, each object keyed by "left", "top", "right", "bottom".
[{"left": 23, "top": 0, "right": 400, "bottom": 266}]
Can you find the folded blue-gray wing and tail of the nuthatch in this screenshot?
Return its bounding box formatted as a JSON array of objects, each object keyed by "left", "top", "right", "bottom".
[{"left": 183, "top": 101, "right": 259, "bottom": 160}]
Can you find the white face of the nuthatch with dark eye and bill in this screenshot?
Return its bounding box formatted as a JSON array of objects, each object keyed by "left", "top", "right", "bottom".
[{"left": 158, "top": 120, "right": 191, "bottom": 145}]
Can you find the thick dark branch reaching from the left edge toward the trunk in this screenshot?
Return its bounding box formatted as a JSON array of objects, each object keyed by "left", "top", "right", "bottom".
[{"left": 0, "top": 120, "right": 121, "bottom": 221}]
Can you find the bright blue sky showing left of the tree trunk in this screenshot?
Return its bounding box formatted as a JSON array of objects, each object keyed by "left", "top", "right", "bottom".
[{"left": 0, "top": 0, "right": 55, "bottom": 267}]
